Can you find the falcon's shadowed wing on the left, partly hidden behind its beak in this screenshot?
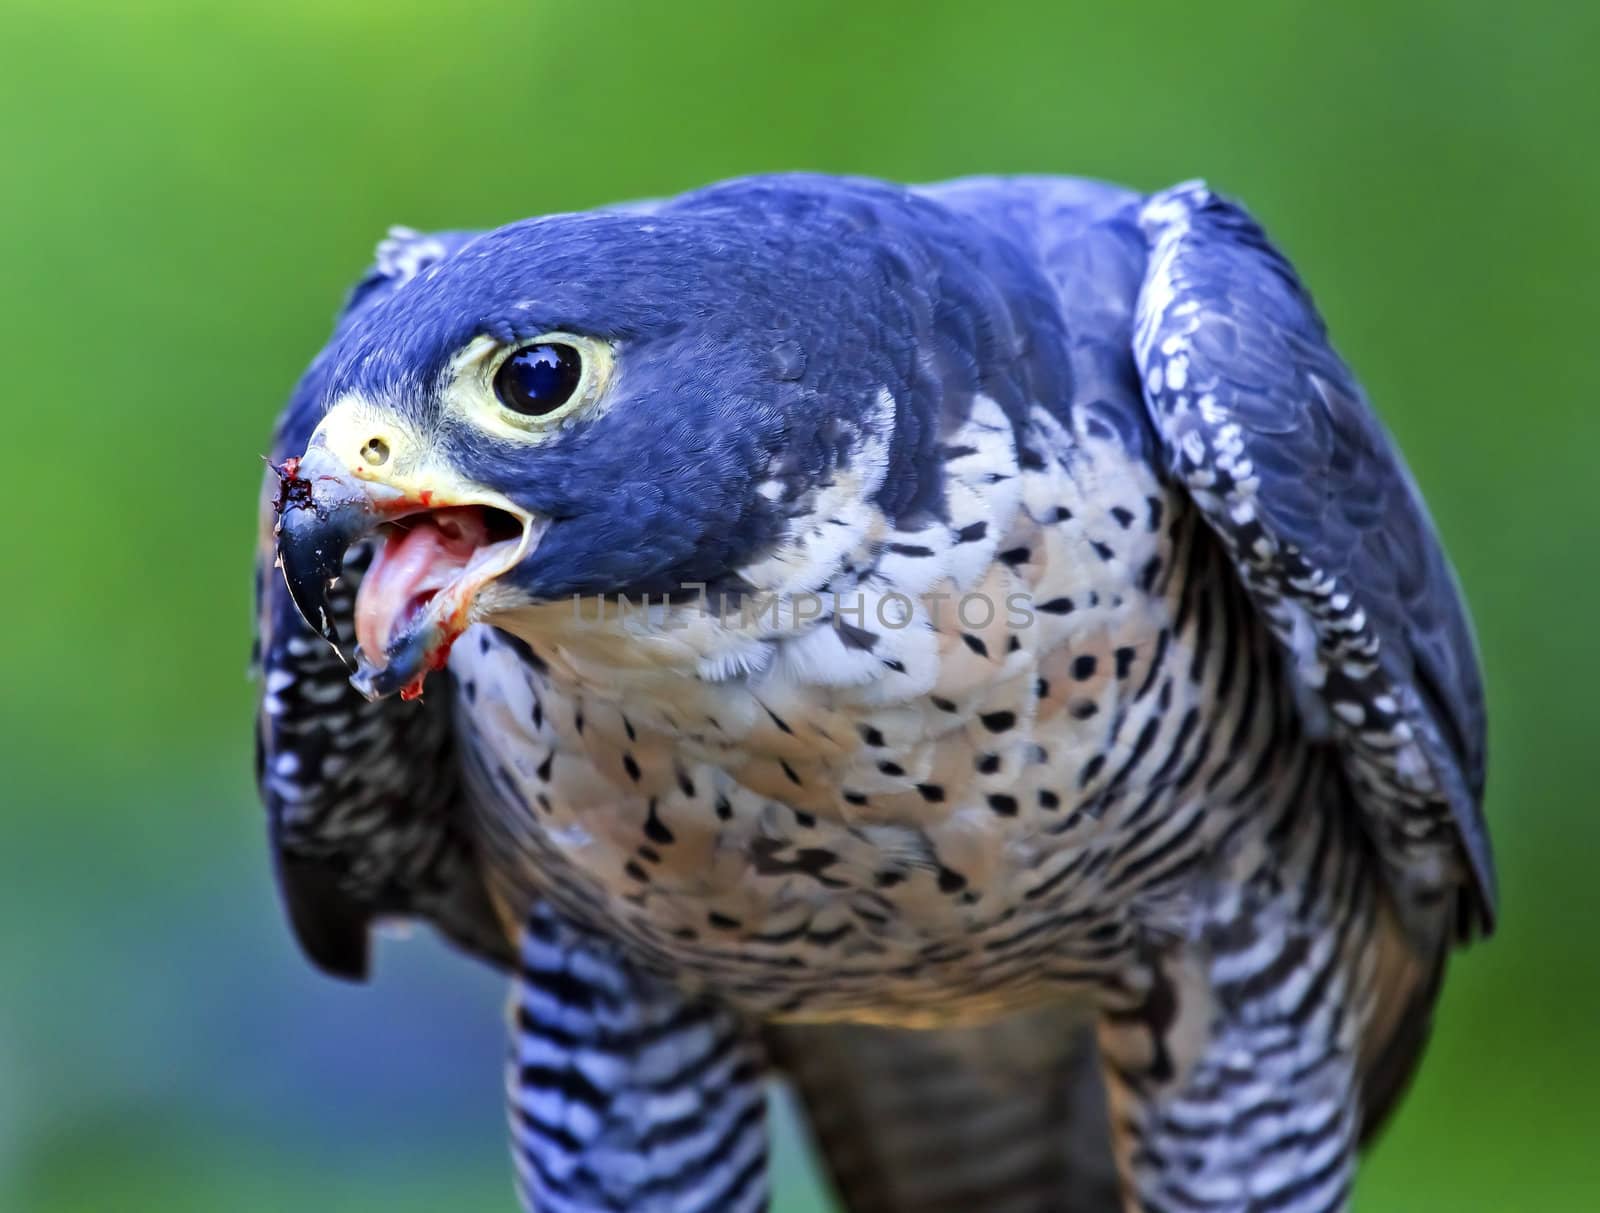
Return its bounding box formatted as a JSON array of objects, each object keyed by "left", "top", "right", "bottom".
[{"left": 254, "top": 229, "right": 509, "bottom": 978}]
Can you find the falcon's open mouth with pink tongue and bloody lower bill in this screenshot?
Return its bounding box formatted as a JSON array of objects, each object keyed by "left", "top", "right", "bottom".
[{"left": 355, "top": 506, "right": 542, "bottom": 696}]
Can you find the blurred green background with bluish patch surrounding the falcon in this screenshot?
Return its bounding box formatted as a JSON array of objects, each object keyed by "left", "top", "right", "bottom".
[{"left": 0, "top": 0, "right": 1600, "bottom": 1213}]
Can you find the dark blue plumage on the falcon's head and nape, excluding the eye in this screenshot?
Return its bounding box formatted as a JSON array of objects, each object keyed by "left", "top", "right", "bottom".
[{"left": 296, "top": 176, "right": 1070, "bottom": 598}]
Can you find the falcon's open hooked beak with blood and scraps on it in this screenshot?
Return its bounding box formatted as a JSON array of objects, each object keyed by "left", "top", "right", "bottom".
[{"left": 277, "top": 437, "right": 546, "bottom": 699}]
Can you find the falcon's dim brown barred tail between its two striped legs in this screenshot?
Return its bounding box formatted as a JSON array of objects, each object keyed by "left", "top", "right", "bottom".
[{"left": 768, "top": 1008, "right": 1120, "bottom": 1213}]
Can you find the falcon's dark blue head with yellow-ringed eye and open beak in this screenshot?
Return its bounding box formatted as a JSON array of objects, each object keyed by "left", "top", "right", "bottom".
[{"left": 278, "top": 184, "right": 1036, "bottom": 695}]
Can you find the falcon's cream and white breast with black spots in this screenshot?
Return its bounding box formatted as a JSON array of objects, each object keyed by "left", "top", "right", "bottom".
[{"left": 451, "top": 408, "right": 1228, "bottom": 1021}]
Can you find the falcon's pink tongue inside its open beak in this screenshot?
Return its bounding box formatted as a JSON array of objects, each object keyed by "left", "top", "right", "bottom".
[{"left": 355, "top": 507, "right": 488, "bottom": 666}]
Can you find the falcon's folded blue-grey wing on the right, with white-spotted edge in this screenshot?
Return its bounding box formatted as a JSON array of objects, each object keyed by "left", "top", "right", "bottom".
[{"left": 1133, "top": 184, "right": 1494, "bottom": 936}]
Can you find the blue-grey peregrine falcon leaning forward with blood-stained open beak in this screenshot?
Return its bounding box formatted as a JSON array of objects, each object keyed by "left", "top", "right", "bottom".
[{"left": 258, "top": 174, "right": 1494, "bottom": 1213}]
